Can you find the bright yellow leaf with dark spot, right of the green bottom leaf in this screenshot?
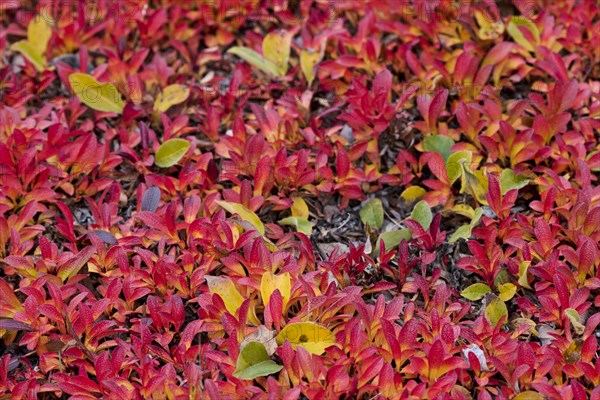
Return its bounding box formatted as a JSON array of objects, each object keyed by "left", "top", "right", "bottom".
[{"left": 277, "top": 322, "right": 336, "bottom": 355}]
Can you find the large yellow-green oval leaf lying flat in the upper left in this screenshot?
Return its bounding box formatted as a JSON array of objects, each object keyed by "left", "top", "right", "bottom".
[{"left": 69, "top": 72, "right": 125, "bottom": 114}]
